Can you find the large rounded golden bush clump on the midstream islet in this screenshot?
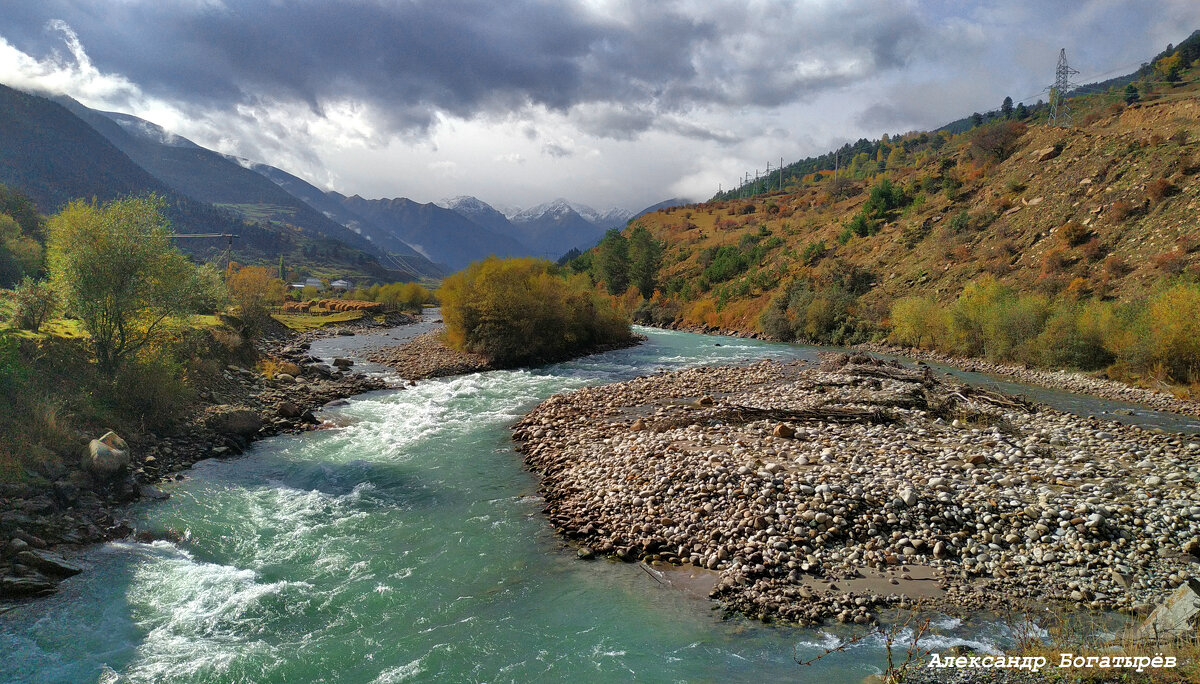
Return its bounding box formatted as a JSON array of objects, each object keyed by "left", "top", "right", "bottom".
[{"left": 438, "top": 257, "right": 630, "bottom": 365}]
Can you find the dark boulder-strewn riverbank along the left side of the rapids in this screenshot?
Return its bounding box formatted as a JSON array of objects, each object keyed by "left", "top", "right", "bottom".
[{"left": 0, "top": 317, "right": 415, "bottom": 599}]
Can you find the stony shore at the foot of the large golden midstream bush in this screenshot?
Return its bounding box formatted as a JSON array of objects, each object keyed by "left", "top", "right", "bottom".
[{"left": 367, "top": 328, "right": 646, "bottom": 382}]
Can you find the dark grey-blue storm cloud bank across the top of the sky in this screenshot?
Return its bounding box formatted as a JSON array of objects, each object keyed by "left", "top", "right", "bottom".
[{"left": 0, "top": 0, "right": 925, "bottom": 139}]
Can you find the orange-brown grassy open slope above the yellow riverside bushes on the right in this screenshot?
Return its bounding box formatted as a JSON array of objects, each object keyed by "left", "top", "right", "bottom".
[{"left": 624, "top": 74, "right": 1200, "bottom": 331}]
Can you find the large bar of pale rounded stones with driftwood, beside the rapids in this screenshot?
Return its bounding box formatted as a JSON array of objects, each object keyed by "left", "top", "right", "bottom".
[{"left": 514, "top": 355, "right": 1200, "bottom": 623}]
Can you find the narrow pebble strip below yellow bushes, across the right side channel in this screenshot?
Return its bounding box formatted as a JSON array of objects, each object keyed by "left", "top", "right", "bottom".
[{"left": 856, "top": 342, "right": 1200, "bottom": 416}]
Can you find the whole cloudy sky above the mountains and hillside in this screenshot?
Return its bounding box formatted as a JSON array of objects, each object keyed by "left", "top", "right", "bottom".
[{"left": 0, "top": 0, "right": 1200, "bottom": 209}]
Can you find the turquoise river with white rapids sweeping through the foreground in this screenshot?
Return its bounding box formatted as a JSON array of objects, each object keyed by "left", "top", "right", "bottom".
[{"left": 0, "top": 328, "right": 1185, "bottom": 684}]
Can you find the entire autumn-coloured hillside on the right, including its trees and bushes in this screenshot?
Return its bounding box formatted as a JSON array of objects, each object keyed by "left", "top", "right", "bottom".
[{"left": 572, "top": 43, "right": 1200, "bottom": 382}]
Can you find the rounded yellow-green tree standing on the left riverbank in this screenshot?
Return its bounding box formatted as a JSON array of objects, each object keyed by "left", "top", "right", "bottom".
[{"left": 46, "top": 196, "right": 220, "bottom": 376}]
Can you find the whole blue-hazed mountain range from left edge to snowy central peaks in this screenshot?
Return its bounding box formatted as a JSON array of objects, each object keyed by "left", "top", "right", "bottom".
[{"left": 0, "top": 88, "right": 682, "bottom": 278}]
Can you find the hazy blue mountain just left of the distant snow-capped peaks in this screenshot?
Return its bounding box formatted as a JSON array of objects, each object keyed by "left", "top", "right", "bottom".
[{"left": 330, "top": 193, "right": 528, "bottom": 271}]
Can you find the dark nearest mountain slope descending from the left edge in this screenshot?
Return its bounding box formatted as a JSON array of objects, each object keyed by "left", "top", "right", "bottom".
[{"left": 0, "top": 85, "right": 406, "bottom": 280}]
